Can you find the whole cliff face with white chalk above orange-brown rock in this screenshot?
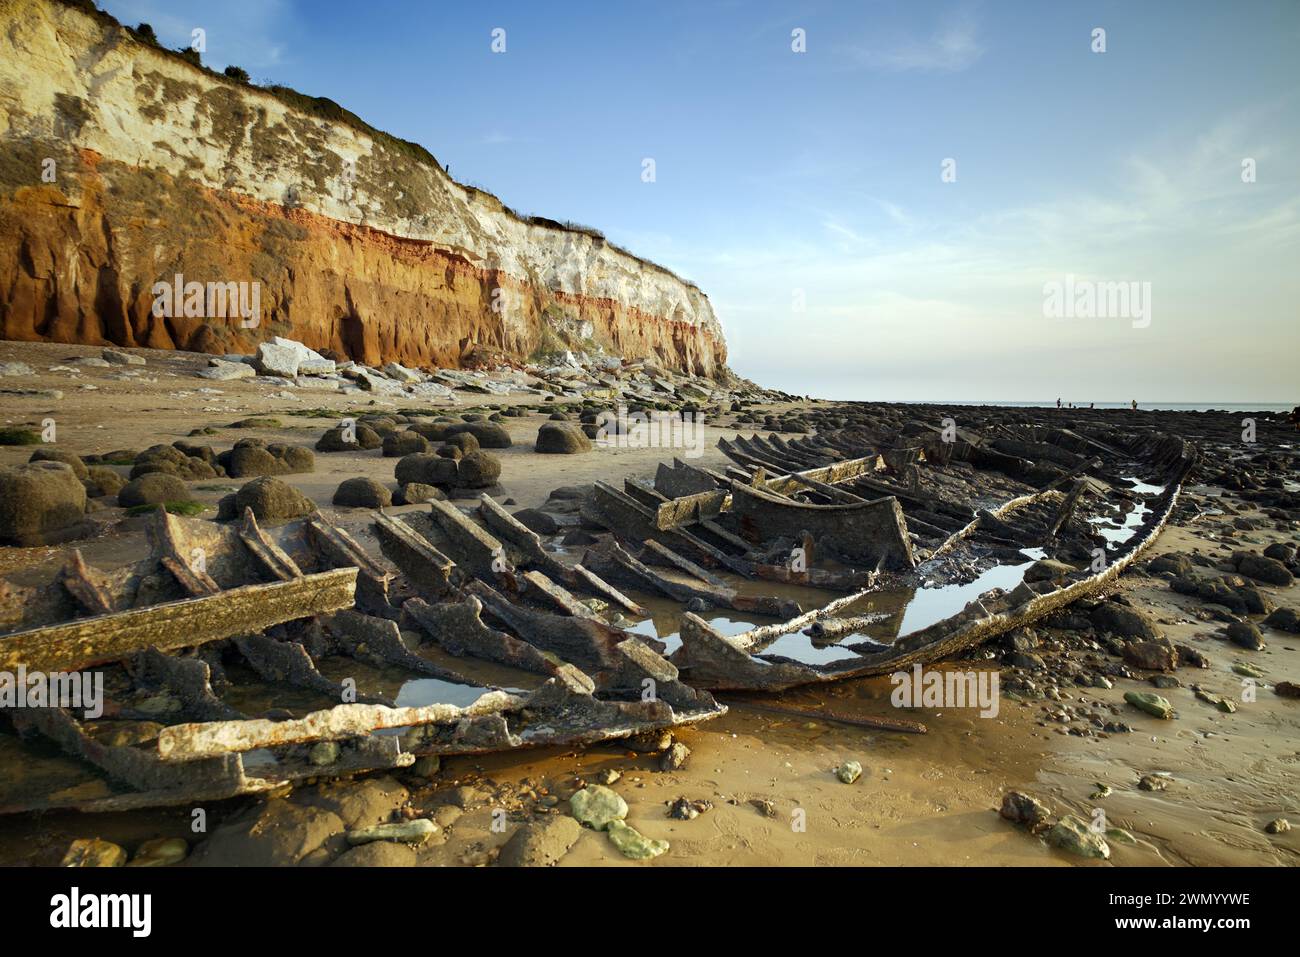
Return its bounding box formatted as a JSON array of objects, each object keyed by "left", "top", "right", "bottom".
[{"left": 0, "top": 0, "right": 727, "bottom": 376}]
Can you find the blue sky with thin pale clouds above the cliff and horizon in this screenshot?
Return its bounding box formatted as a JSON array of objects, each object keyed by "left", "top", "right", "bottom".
[{"left": 101, "top": 0, "right": 1300, "bottom": 403}]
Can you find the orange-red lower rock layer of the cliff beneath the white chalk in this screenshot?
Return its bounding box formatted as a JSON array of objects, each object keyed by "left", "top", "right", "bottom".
[{"left": 0, "top": 150, "right": 727, "bottom": 376}]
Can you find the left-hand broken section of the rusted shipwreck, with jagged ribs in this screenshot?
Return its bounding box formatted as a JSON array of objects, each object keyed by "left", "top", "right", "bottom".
[{"left": 0, "top": 511, "right": 725, "bottom": 813}]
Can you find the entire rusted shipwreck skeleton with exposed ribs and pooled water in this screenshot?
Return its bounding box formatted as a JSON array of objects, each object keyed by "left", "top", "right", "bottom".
[{"left": 0, "top": 407, "right": 1196, "bottom": 813}]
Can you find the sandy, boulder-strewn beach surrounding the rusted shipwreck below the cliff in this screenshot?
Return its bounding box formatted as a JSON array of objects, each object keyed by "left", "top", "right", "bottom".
[{"left": 0, "top": 341, "right": 1300, "bottom": 866}]
